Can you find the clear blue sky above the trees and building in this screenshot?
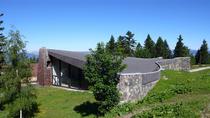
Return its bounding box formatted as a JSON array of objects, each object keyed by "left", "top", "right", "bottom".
[{"left": 0, "top": 0, "right": 210, "bottom": 51}]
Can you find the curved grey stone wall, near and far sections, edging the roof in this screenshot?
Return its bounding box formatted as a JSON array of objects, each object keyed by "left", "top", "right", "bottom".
[{"left": 117, "top": 57, "right": 190, "bottom": 102}]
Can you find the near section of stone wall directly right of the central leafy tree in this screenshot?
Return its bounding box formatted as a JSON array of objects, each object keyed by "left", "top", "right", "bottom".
[{"left": 117, "top": 70, "right": 160, "bottom": 102}]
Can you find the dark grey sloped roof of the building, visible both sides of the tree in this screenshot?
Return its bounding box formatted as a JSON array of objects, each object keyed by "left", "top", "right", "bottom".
[{"left": 48, "top": 49, "right": 159, "bottom": 73}]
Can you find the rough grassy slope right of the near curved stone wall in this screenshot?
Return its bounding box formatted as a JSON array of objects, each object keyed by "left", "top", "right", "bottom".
[{"left": 106, "top": 70, "right": 210, "bottom": 118}]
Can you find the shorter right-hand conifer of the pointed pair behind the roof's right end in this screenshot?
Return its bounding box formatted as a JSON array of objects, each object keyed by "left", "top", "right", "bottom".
[{"left": 155, "top": 37, "right": 165, "bottom": 57}]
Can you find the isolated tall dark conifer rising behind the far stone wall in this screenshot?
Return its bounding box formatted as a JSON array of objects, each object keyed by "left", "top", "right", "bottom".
[{"left": 174, "top": 35, "right": 190, "bottom": 57}]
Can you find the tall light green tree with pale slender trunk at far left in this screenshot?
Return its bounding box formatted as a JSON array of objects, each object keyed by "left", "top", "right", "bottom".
[{"left": 0, "top": 31, "right": 38, "bottom": 118}]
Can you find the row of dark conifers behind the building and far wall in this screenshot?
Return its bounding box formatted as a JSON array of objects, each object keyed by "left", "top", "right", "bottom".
[{"left": 106, "top": 31, "right": 210, "bottom": 64}]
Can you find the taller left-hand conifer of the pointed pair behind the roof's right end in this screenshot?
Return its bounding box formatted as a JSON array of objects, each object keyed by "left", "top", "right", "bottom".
[{"left": 144, "top": 34, "right": 156, "bottom": 57}]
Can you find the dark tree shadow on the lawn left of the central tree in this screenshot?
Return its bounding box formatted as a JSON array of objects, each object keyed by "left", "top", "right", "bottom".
[{"left": 74, "top": 101, "right": 100, "bottom": 117}]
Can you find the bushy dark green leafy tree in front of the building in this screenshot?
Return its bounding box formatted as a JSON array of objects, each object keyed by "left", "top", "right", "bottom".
[{"left": 84, "top": 43, "right": 125, "bottom": 113}]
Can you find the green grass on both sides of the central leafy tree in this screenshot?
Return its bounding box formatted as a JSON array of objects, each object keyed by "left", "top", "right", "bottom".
[{"left": 0, "top": 70, "right": 210, "bottom": 118}]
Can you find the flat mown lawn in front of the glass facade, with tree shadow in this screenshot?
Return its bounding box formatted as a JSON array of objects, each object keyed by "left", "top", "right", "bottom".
[{"left": 36, "top": 87, "right": 96, "bottom": 118}]
